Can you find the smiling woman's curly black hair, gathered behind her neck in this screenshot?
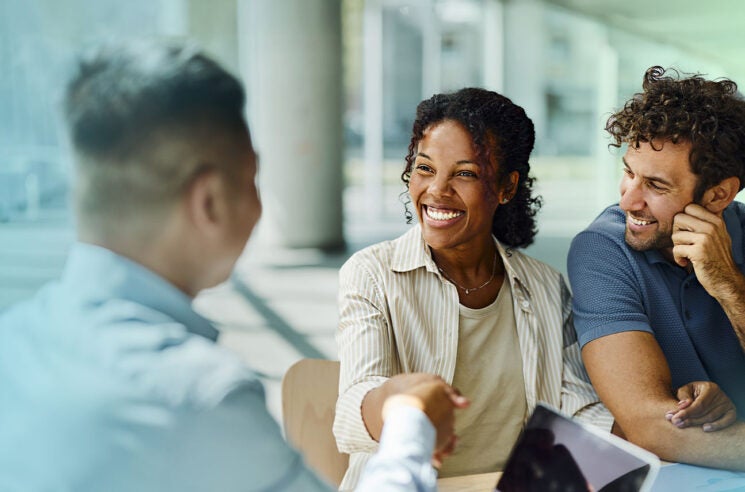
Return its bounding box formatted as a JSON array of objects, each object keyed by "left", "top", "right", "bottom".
[{"left": 401, "top": 88, "right": 541, "bottom": 247}]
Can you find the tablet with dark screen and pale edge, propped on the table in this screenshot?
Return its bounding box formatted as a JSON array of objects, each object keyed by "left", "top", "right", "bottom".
[{"left": 495, "top": 404, "right": 660, "bottom": 492}]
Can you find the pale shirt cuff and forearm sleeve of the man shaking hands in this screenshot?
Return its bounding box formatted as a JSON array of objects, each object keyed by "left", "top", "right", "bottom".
[{"left": 356, "top": 407, "right": 437, "bottom": 492}]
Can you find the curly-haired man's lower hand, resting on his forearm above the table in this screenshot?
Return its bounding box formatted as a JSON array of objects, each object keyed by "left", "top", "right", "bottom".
[{"left": 665, "top": 381, "right": 737, "bottom": 432}]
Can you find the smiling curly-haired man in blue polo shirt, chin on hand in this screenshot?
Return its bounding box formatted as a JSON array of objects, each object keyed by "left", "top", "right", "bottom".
[{"left": 568, "top": 67, "right": 745, "bottom": 469}]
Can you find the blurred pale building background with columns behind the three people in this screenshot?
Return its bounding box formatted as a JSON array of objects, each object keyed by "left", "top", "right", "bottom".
[{"left": 0, "top": 0, "right": 745, "bottom": 416}]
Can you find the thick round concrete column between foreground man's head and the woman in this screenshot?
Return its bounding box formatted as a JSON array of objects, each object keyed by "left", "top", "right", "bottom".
[{"left": 238, "top": 0, "right": 343, "bottom": 248}]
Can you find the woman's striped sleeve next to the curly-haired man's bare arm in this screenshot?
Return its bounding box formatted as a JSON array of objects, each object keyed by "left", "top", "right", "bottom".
[{"left": 559, "top": 277, "right": 613, "bottom": 432}]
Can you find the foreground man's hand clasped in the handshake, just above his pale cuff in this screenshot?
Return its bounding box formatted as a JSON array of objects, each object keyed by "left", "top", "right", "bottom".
[{"left": 382, "top": 373, "right": 470, "bottom": 466}]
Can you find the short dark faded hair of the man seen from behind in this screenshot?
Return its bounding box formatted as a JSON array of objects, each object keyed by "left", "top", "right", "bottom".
[{"left": 64, "top": 42, "right": 247, "bottom": 228}]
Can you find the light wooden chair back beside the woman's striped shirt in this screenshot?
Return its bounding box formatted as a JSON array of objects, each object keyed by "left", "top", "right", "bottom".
[{"left": 282, "top": 359, "right": 349, "bottom": 486}]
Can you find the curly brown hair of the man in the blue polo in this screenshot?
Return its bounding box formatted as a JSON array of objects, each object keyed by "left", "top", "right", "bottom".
[{"left": 605, "top": 66, "right": 745, "bottom": 202}]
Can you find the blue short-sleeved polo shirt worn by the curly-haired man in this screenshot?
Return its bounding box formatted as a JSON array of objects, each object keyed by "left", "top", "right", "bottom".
[{"left": 568, "top": 202, "right": 745, "bottom": 415}]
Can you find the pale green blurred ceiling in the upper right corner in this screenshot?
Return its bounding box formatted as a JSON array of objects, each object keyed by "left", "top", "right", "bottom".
[{"left": 540, "top": 0, "right": 745, "bottom": 80}]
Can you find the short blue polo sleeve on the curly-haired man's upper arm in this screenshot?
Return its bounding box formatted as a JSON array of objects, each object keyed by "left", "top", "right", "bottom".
[{"left": 567, "top": 231, "right": 652, "bottom": 348}]
